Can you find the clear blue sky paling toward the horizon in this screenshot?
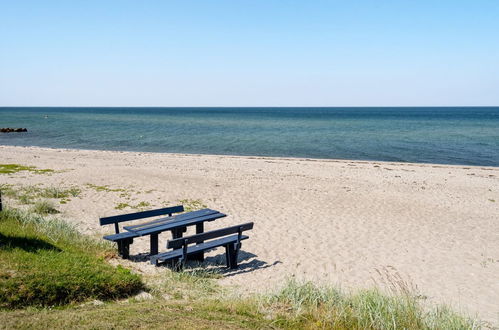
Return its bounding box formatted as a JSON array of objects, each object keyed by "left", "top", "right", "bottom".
[{"left": 0, "top": 0, "right": 499, "bottom": 106}]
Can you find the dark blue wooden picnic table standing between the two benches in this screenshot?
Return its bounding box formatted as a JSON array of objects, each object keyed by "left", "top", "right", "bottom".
[{"left": 123, "top": 209, "right": 227, "bottom": 261}]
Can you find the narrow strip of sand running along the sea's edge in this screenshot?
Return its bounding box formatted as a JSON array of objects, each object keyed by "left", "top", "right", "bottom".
[{"left": 0, "top": 144, "right": 499, "bottom": 170}]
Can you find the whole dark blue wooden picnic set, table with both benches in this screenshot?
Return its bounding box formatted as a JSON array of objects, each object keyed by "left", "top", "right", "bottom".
[{"left": 99, "top": 205, "right": 253, "bottom": 269}]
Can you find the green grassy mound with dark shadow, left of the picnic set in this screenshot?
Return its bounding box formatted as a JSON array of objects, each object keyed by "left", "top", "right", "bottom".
[{"left": 0, "top": 209, "right": 144, "bottom": 308}]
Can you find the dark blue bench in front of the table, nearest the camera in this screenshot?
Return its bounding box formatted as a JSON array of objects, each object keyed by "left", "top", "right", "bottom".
[{"left": 150, "top": 222, "right": 253, "bottom": 269}]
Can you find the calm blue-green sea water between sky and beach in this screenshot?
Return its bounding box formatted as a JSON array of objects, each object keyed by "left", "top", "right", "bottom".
[{"left": 0, "top": 107, "right": 499, "bottom": 166}]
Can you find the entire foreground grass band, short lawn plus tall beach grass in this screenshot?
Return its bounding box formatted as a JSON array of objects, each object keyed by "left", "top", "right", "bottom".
[{"left": 0, "top": 275, "right": 480, "bottom": 329}]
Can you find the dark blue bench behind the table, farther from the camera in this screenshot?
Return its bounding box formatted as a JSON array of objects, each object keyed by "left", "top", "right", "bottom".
[{"left": 99, "top": 205, "right": 184, "bottom": 259}]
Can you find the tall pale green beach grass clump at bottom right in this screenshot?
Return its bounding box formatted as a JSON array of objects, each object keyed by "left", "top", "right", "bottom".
[{"left": 261, "top": 280, "right": 478, "bottom": 329}]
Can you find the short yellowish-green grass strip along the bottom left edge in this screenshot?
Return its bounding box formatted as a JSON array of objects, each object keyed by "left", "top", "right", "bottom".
[{"left": 0, "top": 299, "right": 275, "bottom": 330}]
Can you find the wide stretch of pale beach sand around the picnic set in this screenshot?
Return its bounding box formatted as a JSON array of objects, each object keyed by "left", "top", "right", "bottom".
[{"left": 0, "top": 146, "right": 499, "bottom": 322}]
